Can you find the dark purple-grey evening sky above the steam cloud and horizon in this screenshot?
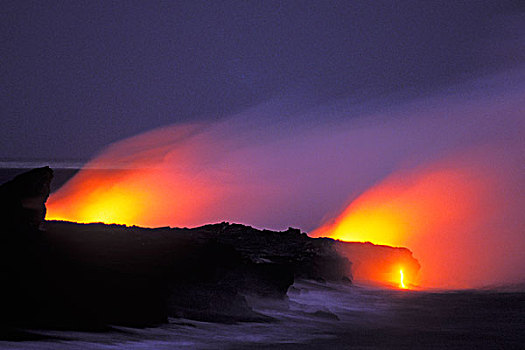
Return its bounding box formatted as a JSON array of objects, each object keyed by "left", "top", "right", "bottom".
[{"left": 0, "top": 0, "right": 525, "bottom": 159}]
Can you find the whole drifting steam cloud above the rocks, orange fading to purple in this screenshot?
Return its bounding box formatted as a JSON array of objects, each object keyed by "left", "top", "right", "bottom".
[{"left": 47, "top": 69, "right": 525, "bottom": 288}]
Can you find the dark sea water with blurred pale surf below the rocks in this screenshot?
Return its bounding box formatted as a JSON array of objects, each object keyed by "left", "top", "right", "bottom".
[{"left": 0, "top": 281, "right": 525, "bottom": 349}]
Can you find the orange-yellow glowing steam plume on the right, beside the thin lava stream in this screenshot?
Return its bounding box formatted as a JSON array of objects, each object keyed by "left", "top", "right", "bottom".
[{"left": 313, "top": 154, "right": 498, "bottom": 289}]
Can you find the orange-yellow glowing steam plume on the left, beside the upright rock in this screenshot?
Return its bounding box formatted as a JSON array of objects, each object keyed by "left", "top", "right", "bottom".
[{"left": 46, "top": 126, "right": 228, "bottom": 227}]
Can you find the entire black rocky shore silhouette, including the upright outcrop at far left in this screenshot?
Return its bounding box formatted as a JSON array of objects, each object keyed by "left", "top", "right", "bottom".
[{"left": 0, "top": 167, "right": 418, "bottom": 330}]
